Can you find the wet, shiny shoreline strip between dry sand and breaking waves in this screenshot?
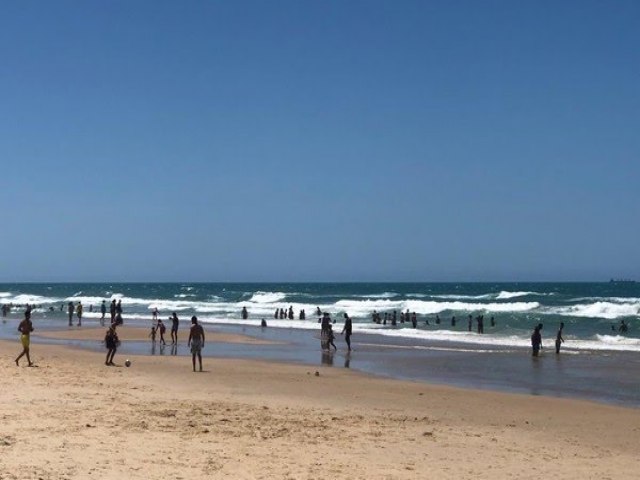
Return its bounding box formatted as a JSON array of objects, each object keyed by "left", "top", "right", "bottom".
[{"left": 0, "top": 319, "right": 640, "bottom": 408}]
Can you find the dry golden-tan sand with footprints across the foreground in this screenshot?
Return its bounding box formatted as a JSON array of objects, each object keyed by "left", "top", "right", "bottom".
[{"left": 0, "top": 332, "right": 640, "bottom": 480}]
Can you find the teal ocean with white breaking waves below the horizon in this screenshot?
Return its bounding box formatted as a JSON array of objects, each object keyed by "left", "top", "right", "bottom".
[{"left": 0, "top": 282, "right": 640, "bottom": 352}]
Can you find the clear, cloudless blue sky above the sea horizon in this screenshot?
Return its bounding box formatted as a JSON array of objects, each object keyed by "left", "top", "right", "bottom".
[{"left": 0, "top": 0, "right": 640, "bottom": 282}]
